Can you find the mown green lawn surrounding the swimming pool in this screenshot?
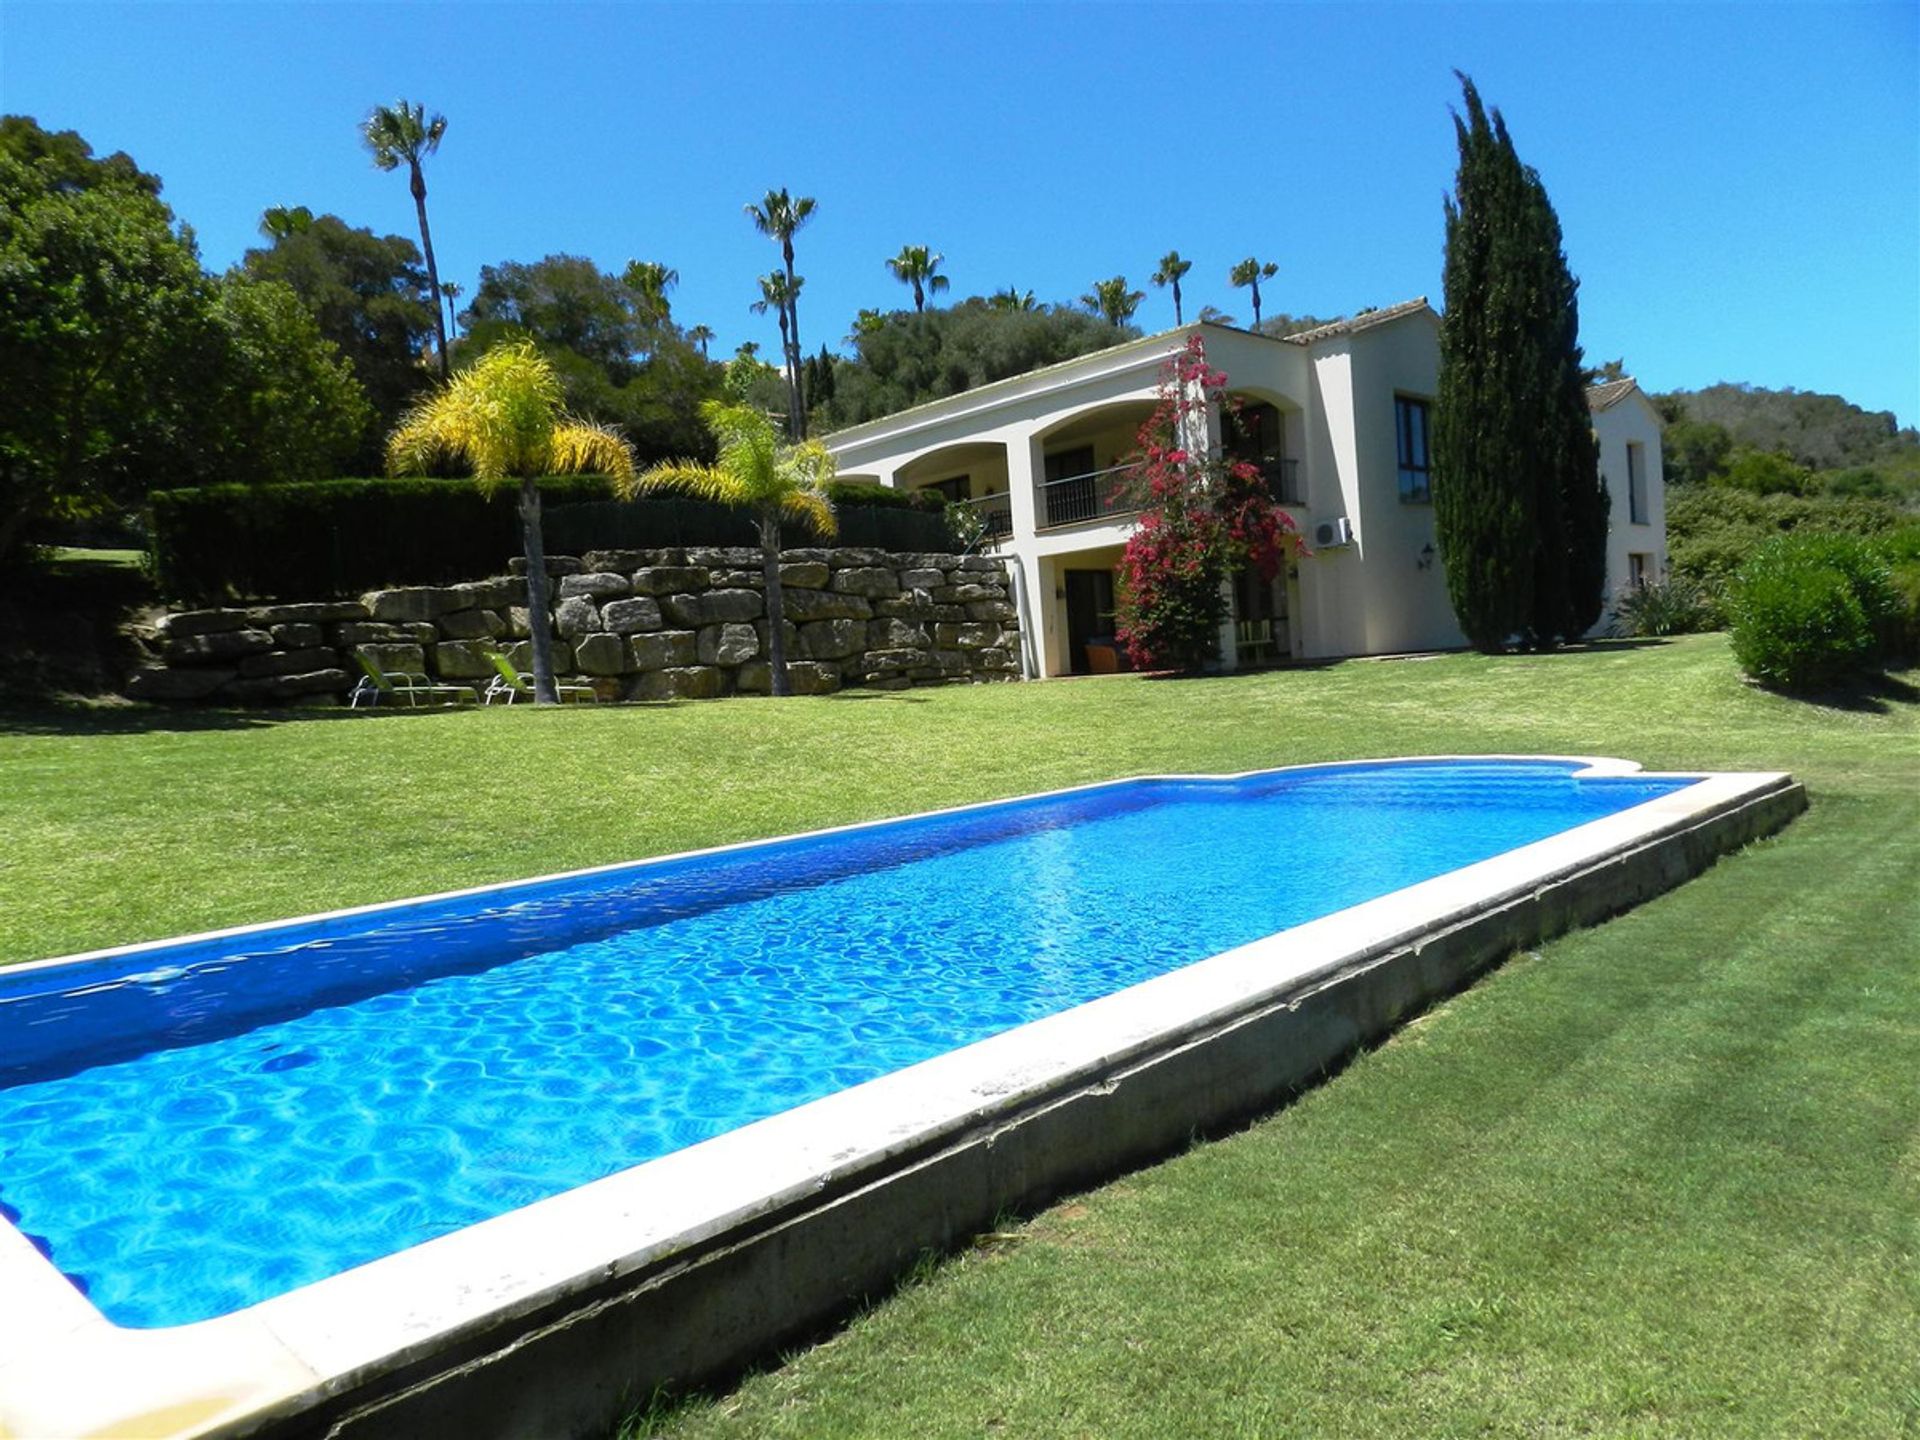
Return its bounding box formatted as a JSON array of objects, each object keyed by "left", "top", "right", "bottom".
[{"left": 0, "top": 636, "right": 1920, "bottom": 1436}]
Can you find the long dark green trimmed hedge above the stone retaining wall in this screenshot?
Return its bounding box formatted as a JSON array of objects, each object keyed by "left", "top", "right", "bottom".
[{"left": 148, "top": 474, "right": 967, "bottom": 603}]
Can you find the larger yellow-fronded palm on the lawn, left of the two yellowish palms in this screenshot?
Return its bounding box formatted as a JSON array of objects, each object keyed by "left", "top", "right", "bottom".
[{"left": 386, "top": 340, "right": 634, "bottom": 705}]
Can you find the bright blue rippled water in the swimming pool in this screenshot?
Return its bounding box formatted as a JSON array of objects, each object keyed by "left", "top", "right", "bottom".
[{"left": 0, "top": 760, "right": 1690, "bottom": 1327}]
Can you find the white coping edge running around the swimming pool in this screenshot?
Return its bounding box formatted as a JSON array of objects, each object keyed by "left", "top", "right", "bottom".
[{"left": 0, "top": 755, "right": 1793, "bottom": 1440}]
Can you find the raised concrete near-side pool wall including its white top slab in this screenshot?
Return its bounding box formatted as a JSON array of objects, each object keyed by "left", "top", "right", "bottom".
[{"left": 0, "top": 762, "right": 1805, "bottom": 1438}]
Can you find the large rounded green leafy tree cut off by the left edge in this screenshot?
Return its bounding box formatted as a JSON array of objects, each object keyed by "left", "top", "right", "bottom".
[{"left": 0, "top": 117, "right": 219, "bottom": 561}]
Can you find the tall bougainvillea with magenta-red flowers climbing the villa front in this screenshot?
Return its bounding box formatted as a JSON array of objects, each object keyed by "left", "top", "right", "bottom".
[{"left": 1117, "top": 336, "right": 1306, "bottom": 670}]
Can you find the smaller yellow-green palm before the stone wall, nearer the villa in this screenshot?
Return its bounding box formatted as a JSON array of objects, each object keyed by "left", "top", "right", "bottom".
[{"left": 622, "top": 401, "right": 835, "bottom": 695}]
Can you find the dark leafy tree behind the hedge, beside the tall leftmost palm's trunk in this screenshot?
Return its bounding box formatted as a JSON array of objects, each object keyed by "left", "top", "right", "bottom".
[{"left": 240, "top": 209, "right": 434, "bottom": 453}]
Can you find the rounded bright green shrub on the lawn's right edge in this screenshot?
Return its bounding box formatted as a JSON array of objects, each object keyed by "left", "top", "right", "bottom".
[{"left": 1732, "top": 534, "right": 1901, "bottom": 691}]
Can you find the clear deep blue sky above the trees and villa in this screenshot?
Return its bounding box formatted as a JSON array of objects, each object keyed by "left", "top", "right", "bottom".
[{"left": 0, "top": 0, "right": 1920, "bottom": 424}]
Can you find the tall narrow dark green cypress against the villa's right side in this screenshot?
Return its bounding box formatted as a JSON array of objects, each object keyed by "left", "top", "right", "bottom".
[{"left": 1432, "top": 75, "right": 1607, "bottom": 651}]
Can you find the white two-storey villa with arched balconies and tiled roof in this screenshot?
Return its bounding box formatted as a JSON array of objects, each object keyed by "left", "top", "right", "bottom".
[{"left": 826, "top": 298, "right": 1667, "bottom": 676}]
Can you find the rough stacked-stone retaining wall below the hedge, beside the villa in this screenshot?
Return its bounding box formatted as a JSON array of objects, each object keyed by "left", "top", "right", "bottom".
[{"left": 127, "top": 549, "right": 1020, "bottom": 705}]
